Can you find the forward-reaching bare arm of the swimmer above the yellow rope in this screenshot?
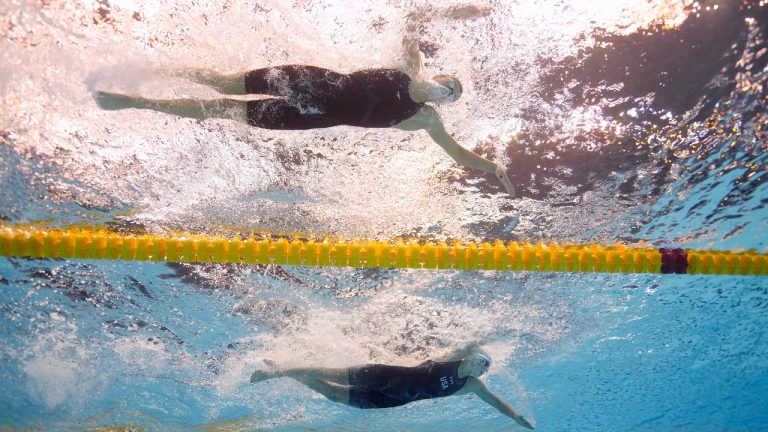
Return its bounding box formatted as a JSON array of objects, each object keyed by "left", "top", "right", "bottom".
[{"left": 395, "top": 105, "right": 515, "bottom": 196}]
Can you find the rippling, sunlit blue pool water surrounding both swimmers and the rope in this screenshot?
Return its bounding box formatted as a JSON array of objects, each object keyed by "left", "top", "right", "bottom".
[{"left": 0, "top": 0, "right": 768, "bottom": 431}]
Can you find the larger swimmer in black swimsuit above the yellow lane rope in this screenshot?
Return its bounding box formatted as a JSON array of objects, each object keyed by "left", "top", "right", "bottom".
[{"left": 94, "top": 43, "right": 515, "bottom": 196}]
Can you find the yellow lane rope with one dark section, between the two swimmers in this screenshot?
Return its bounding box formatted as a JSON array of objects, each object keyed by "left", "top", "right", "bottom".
[{"left": 0, "top": 226, "right": 768, "bottom": 276}]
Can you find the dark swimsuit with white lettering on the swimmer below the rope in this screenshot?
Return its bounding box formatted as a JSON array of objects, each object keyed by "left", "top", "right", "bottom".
[{"left": 349, "top": 360, "right": 467, "bottom": 408}]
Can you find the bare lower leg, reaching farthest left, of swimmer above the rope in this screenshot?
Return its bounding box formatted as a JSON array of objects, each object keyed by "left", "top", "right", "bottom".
[{"left": 94, "top": 92, "right": 247, "bottom": 123}]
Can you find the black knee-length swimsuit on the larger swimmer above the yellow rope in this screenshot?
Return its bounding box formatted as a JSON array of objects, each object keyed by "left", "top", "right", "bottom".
[{"left": 245, "top": 65, "right": 424, "bottom": 129}]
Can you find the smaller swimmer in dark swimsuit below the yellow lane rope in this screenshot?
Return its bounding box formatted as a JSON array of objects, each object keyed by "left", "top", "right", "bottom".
[{"left": 251, "top": 347, "right": 533, "bottom": 429}]
